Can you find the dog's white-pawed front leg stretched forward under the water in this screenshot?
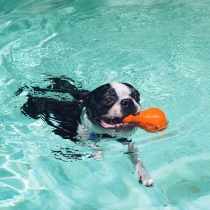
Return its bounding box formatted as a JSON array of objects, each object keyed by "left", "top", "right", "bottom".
[{"left": 128, "top": 143, "right": 154, "bottom": 187}]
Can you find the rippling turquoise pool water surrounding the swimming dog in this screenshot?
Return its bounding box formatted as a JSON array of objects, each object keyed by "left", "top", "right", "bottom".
[{"left": 0, "top": 0, "right": 210, "bottom": 210}]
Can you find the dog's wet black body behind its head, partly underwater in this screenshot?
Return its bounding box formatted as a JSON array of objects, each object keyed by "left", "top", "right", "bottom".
[{"left": 15, "top": 77, "right": 89, "bottom": 142}]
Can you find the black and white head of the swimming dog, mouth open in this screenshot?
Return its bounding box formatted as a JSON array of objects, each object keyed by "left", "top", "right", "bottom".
[{"left": 81, "top": 82, "right": 140, "bottom": 135}]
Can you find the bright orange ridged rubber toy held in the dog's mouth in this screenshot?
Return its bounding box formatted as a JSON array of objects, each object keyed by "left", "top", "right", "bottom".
[{"left": 123, "top": 108, "right": 168, "bottom": 132}]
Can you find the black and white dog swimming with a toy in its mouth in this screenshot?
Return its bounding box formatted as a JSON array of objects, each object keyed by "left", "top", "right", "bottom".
[{"left": 16, "top": 77, "right": 153, "bottom": 186}]
